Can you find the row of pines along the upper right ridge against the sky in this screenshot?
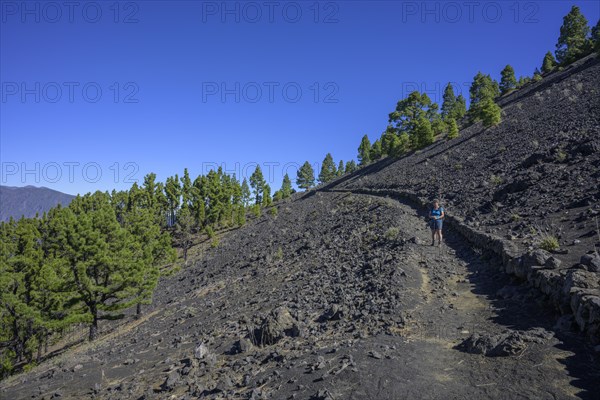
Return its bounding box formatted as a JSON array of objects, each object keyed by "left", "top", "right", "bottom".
[{"left": 358, "top": 6, "right": 600, "bottom": 165}]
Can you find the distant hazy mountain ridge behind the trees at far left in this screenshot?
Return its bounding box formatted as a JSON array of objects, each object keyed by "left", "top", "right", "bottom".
[{"left": 0, "top": 186, "right": 75, "bottom": 221}]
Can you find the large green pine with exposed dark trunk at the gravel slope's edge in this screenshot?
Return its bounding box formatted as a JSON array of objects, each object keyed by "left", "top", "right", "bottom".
[{"left": 58, "top": 192, "right": 152, "bottom": 340}]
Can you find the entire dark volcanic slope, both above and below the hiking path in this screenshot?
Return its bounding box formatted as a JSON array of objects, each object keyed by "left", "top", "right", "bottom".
[{"left": 0, "top": 57, "right": 600, "bottom": 399}]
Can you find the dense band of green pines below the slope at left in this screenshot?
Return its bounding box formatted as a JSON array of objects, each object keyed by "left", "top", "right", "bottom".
[{"left": 0, "top": 166, "right": 294, "bottom": 376}]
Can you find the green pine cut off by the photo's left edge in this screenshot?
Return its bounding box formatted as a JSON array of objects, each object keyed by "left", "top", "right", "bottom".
[{"left": 0, "top": 218, "right": 69, "bottom": 364}]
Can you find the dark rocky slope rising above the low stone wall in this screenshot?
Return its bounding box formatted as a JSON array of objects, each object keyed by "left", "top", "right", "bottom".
[{"left": 335, "top": 56, "right": 600, "bottom": 272}]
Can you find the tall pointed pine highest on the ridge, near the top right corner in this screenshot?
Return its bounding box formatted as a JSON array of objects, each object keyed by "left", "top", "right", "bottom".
[{"left": 556, "top": 6, "right": 591, "bottom": 65}]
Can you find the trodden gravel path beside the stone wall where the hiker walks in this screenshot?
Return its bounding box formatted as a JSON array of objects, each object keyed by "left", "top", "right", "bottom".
[{"left": 328, "top": 189, "right": 600, "bottom": 399}]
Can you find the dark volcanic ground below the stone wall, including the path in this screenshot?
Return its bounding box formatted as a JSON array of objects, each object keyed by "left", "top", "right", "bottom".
[{"left": 0, "top": 191, "right": 600, "bottom": 399}]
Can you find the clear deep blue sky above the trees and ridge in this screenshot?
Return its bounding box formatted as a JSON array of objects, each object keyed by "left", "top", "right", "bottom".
[{"left": 0, "top": 0, "right": 600, "bottom": 193}]
